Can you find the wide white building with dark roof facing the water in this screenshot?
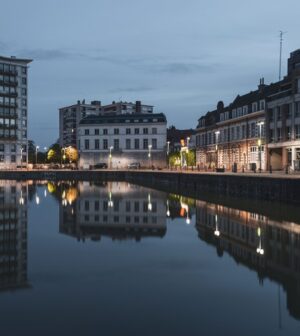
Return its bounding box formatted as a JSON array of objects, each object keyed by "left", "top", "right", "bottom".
[{"left": 78, "top": 112, "right": 167, "bottom": 169}]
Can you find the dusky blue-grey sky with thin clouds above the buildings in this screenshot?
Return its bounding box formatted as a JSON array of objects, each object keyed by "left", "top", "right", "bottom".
[{"left": 0, "top": 0, "right": 300, "bottom": 146}]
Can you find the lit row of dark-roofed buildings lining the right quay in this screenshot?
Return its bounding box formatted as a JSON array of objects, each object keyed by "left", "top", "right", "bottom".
[{"left": 196, "top": 49, "right": 300, "bottom": 171}]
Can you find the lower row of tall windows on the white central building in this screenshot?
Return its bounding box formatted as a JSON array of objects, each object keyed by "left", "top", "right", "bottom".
[{"left": 84, "top": 139, "right": 157, "bottom": 150}]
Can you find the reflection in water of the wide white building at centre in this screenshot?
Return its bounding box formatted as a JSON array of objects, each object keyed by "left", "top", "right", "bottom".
[{"left": 60, "top": 182, "right": 166, "bottom": 240}]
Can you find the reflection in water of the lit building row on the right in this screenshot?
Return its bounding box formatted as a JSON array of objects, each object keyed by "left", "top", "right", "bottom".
[{"left": 196, "top": 201, "right": 300, "bottom": 319}]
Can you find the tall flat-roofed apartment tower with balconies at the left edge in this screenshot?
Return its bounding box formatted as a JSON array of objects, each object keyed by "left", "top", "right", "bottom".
[{"left": 0, "top": 56, "right": 32, "bottom": 169}]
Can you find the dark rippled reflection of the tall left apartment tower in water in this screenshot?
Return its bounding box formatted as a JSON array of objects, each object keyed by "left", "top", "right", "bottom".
[{"left": 0, "top": 181, "right": 28, "bottom": 290}]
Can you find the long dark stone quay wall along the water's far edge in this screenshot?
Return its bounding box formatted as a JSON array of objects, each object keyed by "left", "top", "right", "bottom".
[{"left": 0, "top": 170, "right": 300, "bottom": 204}]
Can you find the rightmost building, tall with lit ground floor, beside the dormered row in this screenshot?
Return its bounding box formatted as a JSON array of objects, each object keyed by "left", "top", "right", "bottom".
[{"left": 266, "top": 49, "right": 300, "bottom": 170}]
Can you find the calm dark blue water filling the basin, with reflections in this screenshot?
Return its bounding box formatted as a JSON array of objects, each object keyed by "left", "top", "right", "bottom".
[{"left": 0, "top": 181, "right": 300, "bottom": 336}]
